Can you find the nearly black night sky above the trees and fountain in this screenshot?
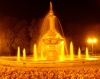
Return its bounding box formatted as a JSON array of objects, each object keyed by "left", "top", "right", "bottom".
[{"left": 0, "top": 0, "right": 100, "bottom": 25}]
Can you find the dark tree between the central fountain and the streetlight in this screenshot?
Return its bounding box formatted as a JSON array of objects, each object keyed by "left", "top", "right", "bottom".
[{"left": 66, "top": 23, "right": 83, "bottom": 54}]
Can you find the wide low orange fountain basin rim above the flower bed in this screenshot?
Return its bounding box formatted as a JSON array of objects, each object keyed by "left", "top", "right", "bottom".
[{"left": 0, "top": 56, "right": 100, "bottom": 67}]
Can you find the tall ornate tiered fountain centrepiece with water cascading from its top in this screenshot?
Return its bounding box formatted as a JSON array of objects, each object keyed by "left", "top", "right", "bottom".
[{"left": 38, "top": 2, "right": 64, "bottom": 60}]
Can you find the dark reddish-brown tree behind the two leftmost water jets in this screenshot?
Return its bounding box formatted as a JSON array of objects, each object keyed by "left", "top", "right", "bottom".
[{"left": 13, "top": 28, "right": 29, "bottom": 53}]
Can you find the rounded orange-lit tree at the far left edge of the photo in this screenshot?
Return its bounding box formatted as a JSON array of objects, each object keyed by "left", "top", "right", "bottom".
[{"left": 1, "top": 29, "right": 15, "bottom": 55}]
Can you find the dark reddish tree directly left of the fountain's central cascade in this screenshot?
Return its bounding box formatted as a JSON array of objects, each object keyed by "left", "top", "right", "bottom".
[{"left": 29, "top": 18, "right": 43, "bottom": 51}]
